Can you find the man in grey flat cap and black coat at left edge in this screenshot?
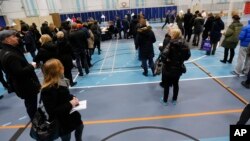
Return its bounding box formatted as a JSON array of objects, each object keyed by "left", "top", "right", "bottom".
[{"left": 0, "top": 30, "right": 40, "bottom": 120}]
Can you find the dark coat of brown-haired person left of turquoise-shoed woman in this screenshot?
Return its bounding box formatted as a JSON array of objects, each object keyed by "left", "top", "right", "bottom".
[{"left": 136, "top": 26, "right": 156, "bottom": 59}]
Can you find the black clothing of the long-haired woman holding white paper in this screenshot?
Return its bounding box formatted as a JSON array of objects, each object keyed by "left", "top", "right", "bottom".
[{"left": 41, "top": 83, "right": 82, "bottom": 136}]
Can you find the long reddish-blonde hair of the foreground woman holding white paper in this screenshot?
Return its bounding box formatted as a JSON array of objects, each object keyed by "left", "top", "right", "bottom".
[{"left": 42, "top": 59, "right": 64, "bottom": 89}]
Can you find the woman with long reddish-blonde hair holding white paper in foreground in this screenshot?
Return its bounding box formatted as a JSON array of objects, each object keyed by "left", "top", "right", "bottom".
[{"left": 41, "top": 59, "right": 83, "bottom": 141}]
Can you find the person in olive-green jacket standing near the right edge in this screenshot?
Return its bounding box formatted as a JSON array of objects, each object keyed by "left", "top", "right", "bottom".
[{"left": 220, "top": 15, "right": 243, "bottom": 63}]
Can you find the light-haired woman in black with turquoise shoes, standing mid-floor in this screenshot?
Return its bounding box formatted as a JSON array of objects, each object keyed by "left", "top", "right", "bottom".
[{"left": 160, "top": 28, "right": 188, "bottom": 106}]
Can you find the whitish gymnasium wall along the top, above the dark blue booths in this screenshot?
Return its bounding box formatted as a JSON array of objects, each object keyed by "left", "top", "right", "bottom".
[{"left": 1, "top": 0, "right": 244, "bottom": 24}]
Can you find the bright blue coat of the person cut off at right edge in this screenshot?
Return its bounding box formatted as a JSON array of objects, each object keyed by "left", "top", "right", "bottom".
[{"left": 239, "top": 20, "right": 250, "bottom": 47}]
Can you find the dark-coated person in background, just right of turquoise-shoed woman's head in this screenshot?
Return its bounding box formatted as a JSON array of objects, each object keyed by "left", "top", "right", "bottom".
[{"left": 183, "top": 9, "right": 193, "bottom": 42}]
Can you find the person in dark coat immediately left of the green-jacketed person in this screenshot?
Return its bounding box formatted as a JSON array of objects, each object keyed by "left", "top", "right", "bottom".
[{"left": 210, "top": 14, "right": 224, "bottom": 55}]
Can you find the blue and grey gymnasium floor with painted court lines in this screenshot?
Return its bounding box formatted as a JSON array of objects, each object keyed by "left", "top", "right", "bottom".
[{"left": 0, "top": 24, "right": 250, "bottom": 141}]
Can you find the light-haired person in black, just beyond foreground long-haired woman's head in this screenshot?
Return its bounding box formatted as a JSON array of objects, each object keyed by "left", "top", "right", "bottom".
[{"left": 56, "top": 31, "right": 77, "bottom": 87}]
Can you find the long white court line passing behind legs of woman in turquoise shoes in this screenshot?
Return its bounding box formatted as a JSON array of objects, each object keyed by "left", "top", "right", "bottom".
[{"left": 70, "top": 75, "right": 241, "bottom": 89}]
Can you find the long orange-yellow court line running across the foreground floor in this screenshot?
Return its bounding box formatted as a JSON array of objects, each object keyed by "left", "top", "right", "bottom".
[{"left": 0, "top": 109, "right": 242, "bottom": 129}]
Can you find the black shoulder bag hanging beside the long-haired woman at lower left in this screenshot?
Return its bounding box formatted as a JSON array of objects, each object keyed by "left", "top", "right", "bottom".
[{"left": 30, "top": 94, "right": 59, "bottom": 140}]
